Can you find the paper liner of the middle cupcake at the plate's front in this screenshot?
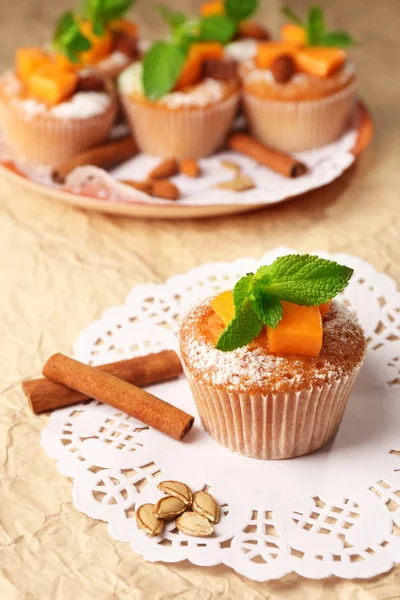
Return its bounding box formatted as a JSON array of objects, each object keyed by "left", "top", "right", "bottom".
[{"left": 122, "top": 93, "right": 239, "bottom": 158}]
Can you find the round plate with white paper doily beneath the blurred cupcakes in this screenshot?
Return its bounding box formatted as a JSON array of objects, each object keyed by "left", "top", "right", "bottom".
[{"left": 0, "top": 102, "right": 373, "bottom": 219}]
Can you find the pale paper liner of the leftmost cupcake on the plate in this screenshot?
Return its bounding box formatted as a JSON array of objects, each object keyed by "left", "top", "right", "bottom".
[{"left": 0, "top": 86, "right": 117, "bottom": 168}]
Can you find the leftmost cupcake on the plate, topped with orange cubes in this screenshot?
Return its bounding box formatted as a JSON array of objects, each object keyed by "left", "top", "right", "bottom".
[{"left": 0, "top": 48, "right": 117, "bottom": 168}]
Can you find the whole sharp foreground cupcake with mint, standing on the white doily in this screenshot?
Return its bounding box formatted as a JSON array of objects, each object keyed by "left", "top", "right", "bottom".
[{"left": 180, "top": 255, "right": 366, "bottom": 459}]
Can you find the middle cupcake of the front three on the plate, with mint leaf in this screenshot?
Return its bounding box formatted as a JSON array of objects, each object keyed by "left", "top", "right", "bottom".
[{"left": 118, "top": 42, "right": 239, "bottom": 158}]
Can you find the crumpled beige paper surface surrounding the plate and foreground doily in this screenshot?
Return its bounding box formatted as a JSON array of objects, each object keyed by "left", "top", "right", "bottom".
[{"left": 0, "top": 0, "right": 400, "bottom": 600}]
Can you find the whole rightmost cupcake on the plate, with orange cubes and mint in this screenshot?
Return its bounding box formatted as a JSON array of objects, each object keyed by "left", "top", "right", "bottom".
[{"left": 240, "top": 7, "right": 357, "bottom": 152}]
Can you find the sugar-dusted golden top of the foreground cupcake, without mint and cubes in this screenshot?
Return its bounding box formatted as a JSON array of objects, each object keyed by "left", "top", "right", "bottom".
[{"left": 180, "top": 299, "right": 366, "bottom": 394}]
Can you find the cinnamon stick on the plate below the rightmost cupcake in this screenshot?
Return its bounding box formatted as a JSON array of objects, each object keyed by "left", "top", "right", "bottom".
[{"left": 227, "top": 133, "right": 308, "bottom": 178}]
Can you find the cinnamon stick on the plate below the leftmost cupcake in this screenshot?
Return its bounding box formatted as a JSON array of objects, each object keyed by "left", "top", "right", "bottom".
[{"left": 52, "top": 135, "right": 138, "bottom": 184}]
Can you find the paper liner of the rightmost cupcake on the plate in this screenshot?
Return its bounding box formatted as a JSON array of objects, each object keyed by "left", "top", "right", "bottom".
[{"left": 243, "top": 81, "right": 357, "bottom": 152}]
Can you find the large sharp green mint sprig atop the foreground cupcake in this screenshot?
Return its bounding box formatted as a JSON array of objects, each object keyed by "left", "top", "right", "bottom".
[{"left": 216, "top": 254, "right": 353, "bottom": 352}]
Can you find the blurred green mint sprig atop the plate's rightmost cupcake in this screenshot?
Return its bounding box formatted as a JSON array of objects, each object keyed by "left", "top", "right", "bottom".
[{"left": 281, "top": 5, "right": 356, "bottom": 48}]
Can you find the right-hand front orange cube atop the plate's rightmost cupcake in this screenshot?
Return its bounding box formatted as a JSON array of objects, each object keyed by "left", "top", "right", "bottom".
[{"left": 294, "top": 46, "right": 346, "bottom": 78}]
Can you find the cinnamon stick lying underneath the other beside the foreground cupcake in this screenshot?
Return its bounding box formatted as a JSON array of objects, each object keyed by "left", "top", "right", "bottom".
[{"left": 22, "top": 350, "right": 182, "bottom": 414}]
